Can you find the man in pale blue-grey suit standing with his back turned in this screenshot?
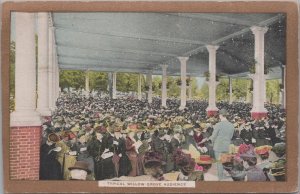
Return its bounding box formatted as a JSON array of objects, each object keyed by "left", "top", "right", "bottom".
[{"left": 209, "top": 109, "right": 234, "bottom": 180}]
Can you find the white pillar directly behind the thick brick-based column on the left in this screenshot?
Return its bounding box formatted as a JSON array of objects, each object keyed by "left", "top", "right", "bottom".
[{"left": 37, "top": 12, "right": 51, "bottom": 116}]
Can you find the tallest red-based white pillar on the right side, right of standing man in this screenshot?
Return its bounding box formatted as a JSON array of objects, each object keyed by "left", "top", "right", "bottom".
[{"left": 251, "top": 26, "right": 268, "bottom": 119}]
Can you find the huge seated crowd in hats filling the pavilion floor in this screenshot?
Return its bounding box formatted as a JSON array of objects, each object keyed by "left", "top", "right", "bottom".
[{"left": 40, "top": 91, "right": 286, "bottom": 181}]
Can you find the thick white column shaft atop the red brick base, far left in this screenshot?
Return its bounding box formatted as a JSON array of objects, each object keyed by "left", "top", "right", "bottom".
[{"left": 10, "top": 12, "right": 41, "bottom": 127}]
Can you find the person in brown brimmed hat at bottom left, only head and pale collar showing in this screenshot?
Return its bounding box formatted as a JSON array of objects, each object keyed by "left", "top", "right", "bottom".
[{"left": 68, "top": 161, "right": 91, "bottom": 180}]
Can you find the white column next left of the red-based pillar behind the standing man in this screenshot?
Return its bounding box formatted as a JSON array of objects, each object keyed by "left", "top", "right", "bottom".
[{"left": 178, "top": 57, "right": 189, "bottom": 110}]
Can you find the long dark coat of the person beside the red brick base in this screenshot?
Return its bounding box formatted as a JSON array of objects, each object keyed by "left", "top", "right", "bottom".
[{"left": 40, "top": 143, "right": 63, "bottom": 180}]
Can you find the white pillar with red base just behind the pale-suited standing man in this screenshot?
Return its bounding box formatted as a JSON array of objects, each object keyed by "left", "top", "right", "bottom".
[{"left": 206, "top": 45, "right": 219, "bottom": 116}]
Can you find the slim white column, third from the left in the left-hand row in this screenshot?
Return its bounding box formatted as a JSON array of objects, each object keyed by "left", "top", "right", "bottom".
[{"left": 48, "top": 26, "right": 55, "bottom": 111}]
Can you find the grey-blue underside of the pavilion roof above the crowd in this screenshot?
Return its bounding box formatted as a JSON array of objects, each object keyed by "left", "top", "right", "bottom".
[{"left": 52, "top": 12, "right": 286, "bottom": 79}]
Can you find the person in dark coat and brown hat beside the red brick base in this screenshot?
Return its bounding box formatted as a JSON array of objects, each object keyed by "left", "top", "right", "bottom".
[{"left": 39, "top": 133, "right": 63, "bottom": 180}]
